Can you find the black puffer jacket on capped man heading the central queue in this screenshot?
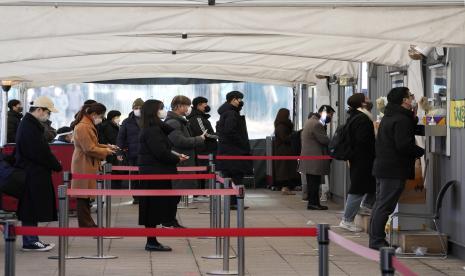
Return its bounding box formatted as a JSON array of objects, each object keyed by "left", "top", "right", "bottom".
[{"left": 216, "top": 103, "right": 253, "bottom": 175}]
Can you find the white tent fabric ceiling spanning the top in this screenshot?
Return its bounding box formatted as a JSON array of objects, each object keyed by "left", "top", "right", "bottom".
[{"left": 0, "top": 4, "right": 465, "bottom": 86}]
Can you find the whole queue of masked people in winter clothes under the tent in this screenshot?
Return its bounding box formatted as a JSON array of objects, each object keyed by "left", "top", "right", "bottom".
[{"left": 2, "top": 87, "right": 424, "bottom": 251}]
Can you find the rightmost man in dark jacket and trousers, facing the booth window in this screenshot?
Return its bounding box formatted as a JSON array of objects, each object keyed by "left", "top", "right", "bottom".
[{"left": 369, "top": 87, "right": 425, "bottom": 249}]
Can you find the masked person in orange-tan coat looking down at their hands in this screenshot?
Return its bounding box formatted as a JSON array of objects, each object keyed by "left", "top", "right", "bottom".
[{"left": 71, "top": 103, "right": 117, "bottom": 227}]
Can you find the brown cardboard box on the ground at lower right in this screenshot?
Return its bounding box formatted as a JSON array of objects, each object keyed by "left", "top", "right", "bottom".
[{"left": 400, "top": 231, "right": 447, "bottom": 253}]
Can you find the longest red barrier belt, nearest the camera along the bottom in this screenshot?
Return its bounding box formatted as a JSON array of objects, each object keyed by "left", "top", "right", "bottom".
[{"left": 16, "top": 226, "right": 317, "bottom": 237}]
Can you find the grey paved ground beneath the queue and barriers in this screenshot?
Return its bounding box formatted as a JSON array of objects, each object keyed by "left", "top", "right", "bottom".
[{"left": 0, "top": 190, "right": 465, "bottom": 276}]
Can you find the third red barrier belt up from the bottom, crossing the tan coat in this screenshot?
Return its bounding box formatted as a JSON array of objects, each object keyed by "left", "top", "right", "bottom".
[{"left": 72, "top": 173, "right": 215, "bottom": 180}]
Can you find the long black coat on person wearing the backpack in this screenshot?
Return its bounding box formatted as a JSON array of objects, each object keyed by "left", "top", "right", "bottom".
[{"left": 346, "top": 110, "right": 376, "bottom": 194}]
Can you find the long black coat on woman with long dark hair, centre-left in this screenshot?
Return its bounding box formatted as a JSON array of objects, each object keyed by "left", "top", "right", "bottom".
[{"left": 137, "top": 123, "right": 179, "bottom": 227}]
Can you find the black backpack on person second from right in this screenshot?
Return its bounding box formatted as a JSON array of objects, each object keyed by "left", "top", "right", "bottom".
[{"left": 328, "top": 114, "right": 363, "bottom": 161}]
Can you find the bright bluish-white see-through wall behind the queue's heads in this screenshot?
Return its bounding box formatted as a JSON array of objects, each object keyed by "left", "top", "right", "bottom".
[{"left": 19, "top": 82, "right": 293, "bottom": 139}]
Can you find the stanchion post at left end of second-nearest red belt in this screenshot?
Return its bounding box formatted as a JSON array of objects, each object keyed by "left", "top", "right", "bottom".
[{"left": 48, "top": 171, "right": 82, "bottom": 260}]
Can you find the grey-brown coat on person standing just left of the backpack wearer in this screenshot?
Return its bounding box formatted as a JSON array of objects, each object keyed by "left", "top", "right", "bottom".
[{"left": 298, "top": 115, "right": 330, "bottom": 175}]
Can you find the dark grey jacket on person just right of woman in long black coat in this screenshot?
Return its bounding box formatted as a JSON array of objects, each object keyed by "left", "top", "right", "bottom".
[{"left": 165, "top": 111, "right": 204, "bottom": 189}]
